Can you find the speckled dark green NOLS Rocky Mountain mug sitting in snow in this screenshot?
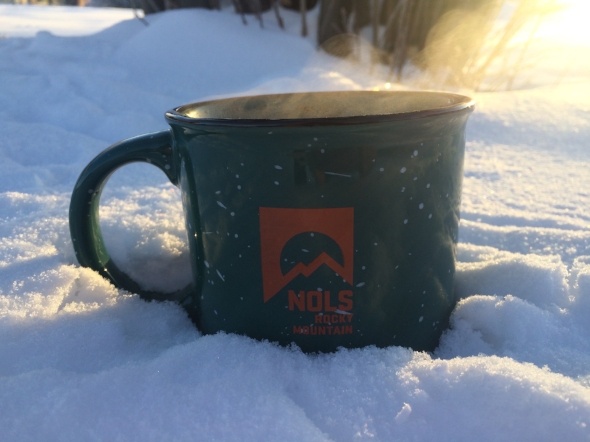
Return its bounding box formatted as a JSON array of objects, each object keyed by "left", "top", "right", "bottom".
[{"left": 70, "top": 91, "right": 474, "bottom": 352}]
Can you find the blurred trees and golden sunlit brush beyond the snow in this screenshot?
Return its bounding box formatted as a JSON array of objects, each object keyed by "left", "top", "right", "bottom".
[{"left": 0, "top": 0, "right": 590, "bottom": 91}]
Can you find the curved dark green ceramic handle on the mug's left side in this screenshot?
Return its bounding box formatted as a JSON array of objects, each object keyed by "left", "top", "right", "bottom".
[{"left": 69, "top": 130, "right": 191, "bottom": 301}]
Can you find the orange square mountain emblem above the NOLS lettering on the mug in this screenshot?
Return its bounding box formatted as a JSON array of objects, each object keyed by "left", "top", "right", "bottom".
[{"left": 260, "top": 207, "right": 354, "bottom": 302}]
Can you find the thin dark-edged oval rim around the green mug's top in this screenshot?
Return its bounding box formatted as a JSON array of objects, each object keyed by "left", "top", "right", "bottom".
[{"left": 165, "top": 90, "right": 475, "bottom": 127}]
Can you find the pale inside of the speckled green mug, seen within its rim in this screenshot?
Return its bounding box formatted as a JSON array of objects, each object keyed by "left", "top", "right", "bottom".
[{"left": 166, "top": 91, "right": 473, "bottom": 124}]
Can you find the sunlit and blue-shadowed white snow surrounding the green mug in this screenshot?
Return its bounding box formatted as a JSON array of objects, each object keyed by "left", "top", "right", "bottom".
[{"left": 0, "top": 5, "right": 590, "bottom": 441}]
